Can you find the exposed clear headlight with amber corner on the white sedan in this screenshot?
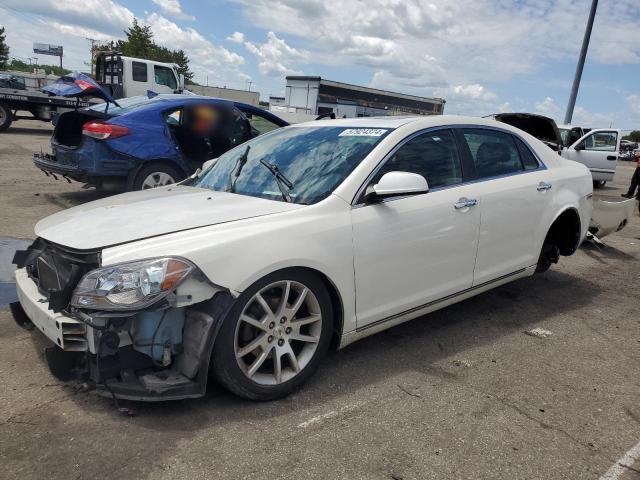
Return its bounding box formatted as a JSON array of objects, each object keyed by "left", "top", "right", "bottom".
[{"left": 71, "top": 258, "right": 195, "bottom": 310}]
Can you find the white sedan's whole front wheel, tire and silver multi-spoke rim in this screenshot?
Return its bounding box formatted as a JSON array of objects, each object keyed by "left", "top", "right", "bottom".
[{"left": 212, "top": 269, "right": 333, "bottom": 401}]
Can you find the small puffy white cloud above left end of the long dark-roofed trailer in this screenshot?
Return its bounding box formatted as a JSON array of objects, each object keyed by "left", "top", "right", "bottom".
[{"left": 241, "top": 32, "right": 307, "bottom": 76}]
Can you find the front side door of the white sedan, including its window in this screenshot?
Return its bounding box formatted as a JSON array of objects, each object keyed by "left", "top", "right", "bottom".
[{"left": 352, "top": 129, "right": 480, "bottom": 328}]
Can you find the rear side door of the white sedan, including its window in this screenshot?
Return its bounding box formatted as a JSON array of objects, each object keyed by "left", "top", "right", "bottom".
[{"left": 459, "top": 128, "right": 553, "bottom": 285}]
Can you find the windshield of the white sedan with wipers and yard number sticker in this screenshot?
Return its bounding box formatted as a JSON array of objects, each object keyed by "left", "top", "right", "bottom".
[{"left": 192, "top": 127, "right": 391, "bottom": 204}]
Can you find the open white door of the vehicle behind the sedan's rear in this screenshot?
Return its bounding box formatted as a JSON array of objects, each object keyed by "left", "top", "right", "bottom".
[{"left": 562, "top": 129, "right": 620, "bottom": 181}]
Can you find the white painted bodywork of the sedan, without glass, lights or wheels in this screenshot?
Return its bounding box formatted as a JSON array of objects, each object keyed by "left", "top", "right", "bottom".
[{"left": 28, "top": 116, "right": 592, "bottom": 345}]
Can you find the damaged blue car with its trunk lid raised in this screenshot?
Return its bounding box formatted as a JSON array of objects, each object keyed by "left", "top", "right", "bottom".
[{"left": 34, "top": 74, "right": 288, "bottom": 190}]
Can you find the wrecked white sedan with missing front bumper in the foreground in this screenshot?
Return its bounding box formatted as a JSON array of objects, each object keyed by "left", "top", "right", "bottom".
[{"left": 12, "top": 116, "right": 592, "bottom": 400}]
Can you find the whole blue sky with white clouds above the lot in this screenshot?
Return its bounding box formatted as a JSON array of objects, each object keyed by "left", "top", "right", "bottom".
[{"left": 0, "top": 0, "right": 640, "bottom": 130}]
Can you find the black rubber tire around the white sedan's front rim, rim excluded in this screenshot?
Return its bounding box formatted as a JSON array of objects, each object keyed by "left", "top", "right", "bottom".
[{"left": 211, "top": 269, "right": 333, "bottom": 401}]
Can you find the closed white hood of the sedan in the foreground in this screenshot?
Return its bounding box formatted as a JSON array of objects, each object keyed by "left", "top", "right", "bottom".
[{"left": 35, "top": 185, "right": 304, "bottom": 250}]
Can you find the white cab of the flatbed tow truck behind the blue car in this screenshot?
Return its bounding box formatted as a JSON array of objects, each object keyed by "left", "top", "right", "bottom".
[{"left": 95, "top": 52, "right": 184, "bottom": 99}]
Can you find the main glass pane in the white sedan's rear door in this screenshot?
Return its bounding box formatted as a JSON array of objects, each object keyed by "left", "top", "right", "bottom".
[{"left": 462, "top": 129, "right": 524, "bottom": 178}]
